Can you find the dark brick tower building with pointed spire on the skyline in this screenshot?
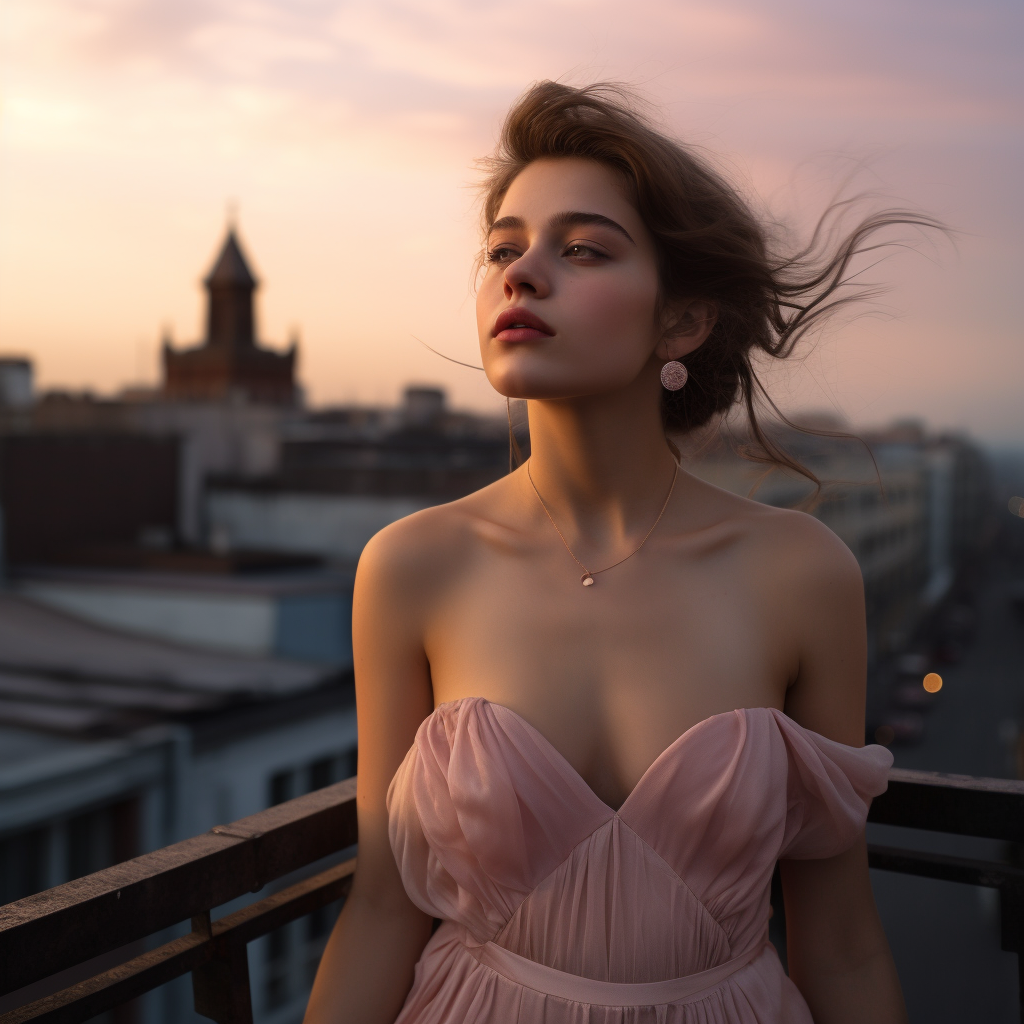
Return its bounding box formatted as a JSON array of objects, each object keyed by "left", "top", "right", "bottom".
[{"left": 163, "top": 228, "right": 297, "bottom": 406}]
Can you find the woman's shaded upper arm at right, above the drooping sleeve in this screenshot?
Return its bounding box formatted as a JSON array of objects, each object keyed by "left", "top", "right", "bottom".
[{"left": 780, "top": 515, "right": 867, "bottom": 746}]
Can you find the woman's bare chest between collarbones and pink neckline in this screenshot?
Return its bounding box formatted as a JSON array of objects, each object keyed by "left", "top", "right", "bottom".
[{"left": 425, "top": 544, "right": 794, "bottom": 774}]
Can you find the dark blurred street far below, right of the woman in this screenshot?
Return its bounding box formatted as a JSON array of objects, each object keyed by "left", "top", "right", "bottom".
[{"left": 868, "top": 550, "right": 1024, "bottom": 1024}]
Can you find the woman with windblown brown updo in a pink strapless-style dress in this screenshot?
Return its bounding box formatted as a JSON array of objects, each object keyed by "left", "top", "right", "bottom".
[{"left": 306, "top": 82, "right": 914, "bottom": 1024}]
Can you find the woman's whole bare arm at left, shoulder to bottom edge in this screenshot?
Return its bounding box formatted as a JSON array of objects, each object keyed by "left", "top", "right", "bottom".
[{"left": 305, "top": 515, "right": 448, "bottom": 1024}]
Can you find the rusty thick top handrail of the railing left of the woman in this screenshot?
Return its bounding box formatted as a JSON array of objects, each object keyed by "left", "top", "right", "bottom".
[{"left": 0, "top": 778, "right": 356, "bottom": 994}]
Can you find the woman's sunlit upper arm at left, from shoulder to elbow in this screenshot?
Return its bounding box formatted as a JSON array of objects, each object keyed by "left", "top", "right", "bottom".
[{"left": 352, "top": 517, "right": 433, "bottom": 898}]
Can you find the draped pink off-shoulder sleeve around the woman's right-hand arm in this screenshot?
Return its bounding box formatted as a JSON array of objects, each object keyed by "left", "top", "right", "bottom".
[{"left": 775, "top": 713, "right": 893, "bottom": 860}]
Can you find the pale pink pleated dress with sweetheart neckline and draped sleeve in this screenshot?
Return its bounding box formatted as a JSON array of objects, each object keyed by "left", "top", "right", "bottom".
[{"left": 388, "top": 697, "right": 892, "bottom": 1024}]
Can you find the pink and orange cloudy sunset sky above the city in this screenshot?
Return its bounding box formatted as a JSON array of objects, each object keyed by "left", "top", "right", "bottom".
[{"left": 0, "top": 0, "right": 1024, "bottom": 444}]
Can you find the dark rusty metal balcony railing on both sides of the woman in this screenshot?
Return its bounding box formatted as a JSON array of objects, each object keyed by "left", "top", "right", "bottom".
[{"left": 0, "top": 769, "right": 1024, "bottom": 1024}]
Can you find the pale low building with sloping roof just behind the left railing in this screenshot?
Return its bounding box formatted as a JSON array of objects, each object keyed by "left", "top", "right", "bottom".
[{"left": 0, "top": 592, "right": 356, "bottom": 1024}]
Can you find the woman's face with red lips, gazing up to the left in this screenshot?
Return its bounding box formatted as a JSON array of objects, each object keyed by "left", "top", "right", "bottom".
[{"left": 476, "top": 159, "right": 664, "bottom": 398}]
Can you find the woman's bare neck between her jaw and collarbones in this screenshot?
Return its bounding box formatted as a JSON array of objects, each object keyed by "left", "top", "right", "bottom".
[{"left": 527, "top": 380, "right": 675, "bottom": 544}]
